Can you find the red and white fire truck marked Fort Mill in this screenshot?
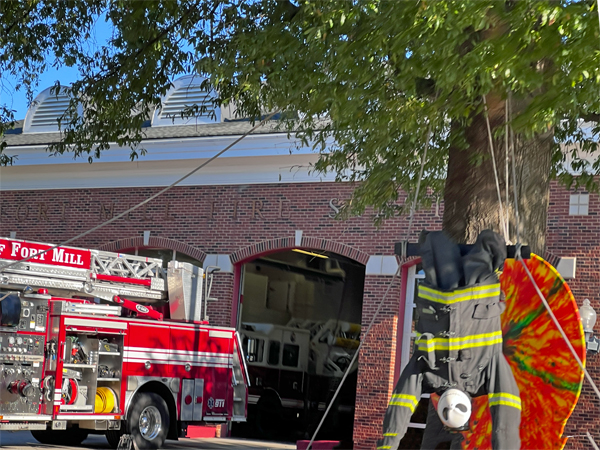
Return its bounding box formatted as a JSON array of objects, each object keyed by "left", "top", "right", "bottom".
[{"left": 0, "top": 238, "right": 248, "bottom": 449}]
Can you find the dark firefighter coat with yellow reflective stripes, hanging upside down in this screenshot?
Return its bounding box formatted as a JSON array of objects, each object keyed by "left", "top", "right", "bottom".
[{"left": 377, "top": 283, "right": 521, "bottom": 450}]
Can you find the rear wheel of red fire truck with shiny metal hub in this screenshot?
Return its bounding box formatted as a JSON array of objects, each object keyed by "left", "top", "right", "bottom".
[{"left": 127, "top": 392, "right": 169, "bottom": 449}]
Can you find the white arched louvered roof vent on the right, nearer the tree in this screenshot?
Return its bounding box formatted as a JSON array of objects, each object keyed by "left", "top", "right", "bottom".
[{"left": 151, "top": 75, "right": 221, "bottom": 127}]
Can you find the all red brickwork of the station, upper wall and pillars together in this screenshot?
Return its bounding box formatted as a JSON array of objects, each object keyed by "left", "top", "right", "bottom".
[{"left": 0, "top": 183, "right": 600, "bottom": 449}]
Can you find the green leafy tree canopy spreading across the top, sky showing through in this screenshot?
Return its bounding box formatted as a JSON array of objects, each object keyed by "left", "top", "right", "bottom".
[{"left": 0, "top": 0, "right": 600, "bottom": 216}]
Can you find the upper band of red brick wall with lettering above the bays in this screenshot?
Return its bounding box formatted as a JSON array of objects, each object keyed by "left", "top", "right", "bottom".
[{"left": 0, "top": 183, "right": 441, "bottom": 251}]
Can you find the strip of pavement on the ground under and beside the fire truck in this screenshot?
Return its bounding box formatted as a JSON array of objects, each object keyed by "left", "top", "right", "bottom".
[{"left": 0, "top": 431, "right": 296, "bottom": 450}]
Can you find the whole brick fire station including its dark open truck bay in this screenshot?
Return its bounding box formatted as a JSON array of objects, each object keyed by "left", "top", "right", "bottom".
[{"left": 0, "top": 77, "right": 600, "bottom": 449}]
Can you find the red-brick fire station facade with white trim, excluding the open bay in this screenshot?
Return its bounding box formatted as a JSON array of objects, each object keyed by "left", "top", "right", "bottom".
[{"left": 0, "top": 79, "right": 600, "bottom": 449}]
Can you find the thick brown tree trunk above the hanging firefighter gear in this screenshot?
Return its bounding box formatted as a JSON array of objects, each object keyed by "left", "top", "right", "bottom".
[{"left": 443, "top": 95, "right": 552, "bottom": 256}]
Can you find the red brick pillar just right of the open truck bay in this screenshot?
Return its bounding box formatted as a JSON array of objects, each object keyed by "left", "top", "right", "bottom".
[{"left": 353, "top": 275, "right": 400, "bottom": 450}]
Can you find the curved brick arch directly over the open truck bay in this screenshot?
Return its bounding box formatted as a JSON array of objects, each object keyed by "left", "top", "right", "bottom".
[{"left": 230, "top": 236, "right": 369, "bottom": 265}]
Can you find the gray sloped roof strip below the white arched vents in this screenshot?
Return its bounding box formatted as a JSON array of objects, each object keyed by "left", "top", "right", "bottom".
[{"left": 2, "top": 120, "right": 285, "bottom": 147}]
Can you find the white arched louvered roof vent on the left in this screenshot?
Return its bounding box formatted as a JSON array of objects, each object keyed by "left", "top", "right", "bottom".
[{"left": 23, "top": 87, "right": 81, "bottom": 133}]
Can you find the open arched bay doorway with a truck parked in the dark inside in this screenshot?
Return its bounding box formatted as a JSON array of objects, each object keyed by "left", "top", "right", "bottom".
[{"left": 233, "top": 248, "right": 365, "bottom": 441}]
